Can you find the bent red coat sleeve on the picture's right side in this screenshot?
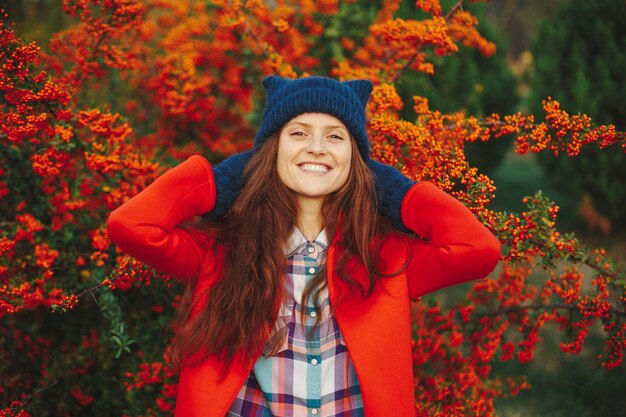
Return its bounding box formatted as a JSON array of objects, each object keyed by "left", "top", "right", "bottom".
[{"left": 401, "top": 181, "right": 501, "bottom": 298}]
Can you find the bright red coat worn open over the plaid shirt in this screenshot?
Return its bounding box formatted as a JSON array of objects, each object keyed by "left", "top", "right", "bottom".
[{"left": 107, "top": 156, "right": 500, "bottom": 417}]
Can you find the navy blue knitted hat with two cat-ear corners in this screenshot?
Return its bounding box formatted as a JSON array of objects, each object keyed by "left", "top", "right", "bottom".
[{"left": 254, "top": 75, "right": 373, "bottom": 161}]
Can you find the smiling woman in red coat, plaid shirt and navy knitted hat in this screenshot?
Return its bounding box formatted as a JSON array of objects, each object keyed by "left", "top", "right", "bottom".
[{"left": 108, "top": 77, "right": 500, "bottom": 417}]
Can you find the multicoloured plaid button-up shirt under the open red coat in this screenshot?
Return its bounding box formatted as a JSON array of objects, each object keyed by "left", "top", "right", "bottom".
[{"left": 227, "top": 229, "right": 363, "bottom": 417}]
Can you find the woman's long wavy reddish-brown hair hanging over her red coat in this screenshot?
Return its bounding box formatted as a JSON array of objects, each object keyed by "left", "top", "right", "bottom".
[{"left": 171, "top": 134, "right": 390, "bottom": 370}]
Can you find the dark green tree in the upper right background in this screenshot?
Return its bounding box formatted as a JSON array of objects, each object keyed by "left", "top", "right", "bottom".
[{"left": 528, "top": 0, "right": 626, "bottom": 232}]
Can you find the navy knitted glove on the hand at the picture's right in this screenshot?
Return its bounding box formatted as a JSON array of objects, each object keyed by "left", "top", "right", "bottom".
[{"left": 367, "top": 158, "right": 415, "bottom": 233}]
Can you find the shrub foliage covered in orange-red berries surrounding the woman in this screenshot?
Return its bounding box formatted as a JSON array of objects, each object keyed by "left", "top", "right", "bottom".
[{"left": 0, "top": 0, "right": 626, "bottom": 416}]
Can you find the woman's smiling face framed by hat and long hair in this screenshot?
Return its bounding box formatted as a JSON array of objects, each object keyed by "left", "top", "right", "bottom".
[{"left": 277, "top": 113, "right": 352, "bottom": 206}]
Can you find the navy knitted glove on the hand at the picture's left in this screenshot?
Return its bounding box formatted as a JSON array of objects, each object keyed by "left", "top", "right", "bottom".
[{"left": 202, "top": 149, "right": 254, "bottom": 221}]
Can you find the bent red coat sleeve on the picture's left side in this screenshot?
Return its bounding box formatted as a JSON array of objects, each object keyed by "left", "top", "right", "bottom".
[{"left": 107, "top": 155, "right": 215, "bottom": 278}]
